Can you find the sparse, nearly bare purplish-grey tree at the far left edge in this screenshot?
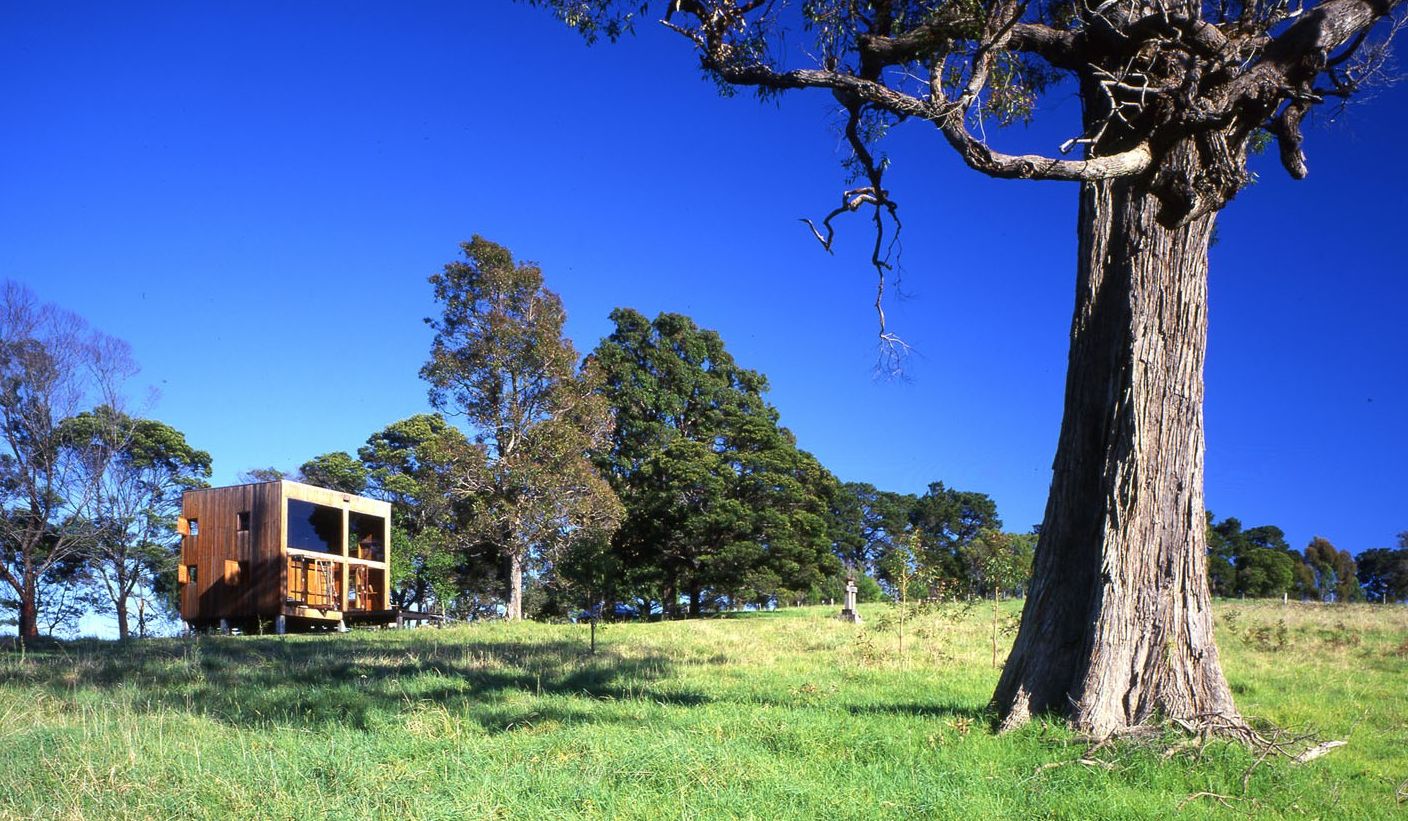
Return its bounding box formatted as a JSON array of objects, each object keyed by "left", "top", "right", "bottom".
[{"left": 0, "top": 282, "right": 135, "bottom": 638}]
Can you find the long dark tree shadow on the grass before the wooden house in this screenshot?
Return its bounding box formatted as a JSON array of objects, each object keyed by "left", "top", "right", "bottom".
[{"left": 0, "top": 631, "right": 708, "bottom": 732}]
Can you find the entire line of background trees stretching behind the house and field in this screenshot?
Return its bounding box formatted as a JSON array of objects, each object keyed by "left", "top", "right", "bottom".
[{"left": 11, "top": 237, "right": 1408, "bottom": 638}]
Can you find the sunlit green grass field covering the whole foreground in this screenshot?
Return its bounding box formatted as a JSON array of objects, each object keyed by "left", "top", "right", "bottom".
[{"left": 0, "top": 603, "right": 1408, "bottom": 820}]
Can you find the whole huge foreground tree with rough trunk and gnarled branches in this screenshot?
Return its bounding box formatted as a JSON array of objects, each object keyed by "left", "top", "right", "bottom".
[{"left": 532, "top": 0, "right": 1408, "bottom": 735}]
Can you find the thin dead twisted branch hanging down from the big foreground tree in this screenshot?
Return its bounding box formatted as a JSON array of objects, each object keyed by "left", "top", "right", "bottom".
[{"left": 801, "top": 100, "right": 911, "bottom": 376}]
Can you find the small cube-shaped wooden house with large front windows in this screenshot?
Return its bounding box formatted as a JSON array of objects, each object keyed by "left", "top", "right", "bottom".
[{"left": 176, "top": 480, "right": 391, "bottom": 632}]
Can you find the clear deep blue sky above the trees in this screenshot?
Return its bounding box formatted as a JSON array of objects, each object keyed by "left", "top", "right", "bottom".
[{"left": 0, "top": 0, "right": 1408, "bottom": 552}]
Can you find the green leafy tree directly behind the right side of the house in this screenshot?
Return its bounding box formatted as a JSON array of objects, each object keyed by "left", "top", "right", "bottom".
[{"left": 358, "top": 414, "right": 498, "bottom": 611}]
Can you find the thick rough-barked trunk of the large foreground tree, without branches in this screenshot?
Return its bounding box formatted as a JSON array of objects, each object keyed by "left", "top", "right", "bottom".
[{"left": 993, "top": 161, "right": 1236, "bottom": 737}]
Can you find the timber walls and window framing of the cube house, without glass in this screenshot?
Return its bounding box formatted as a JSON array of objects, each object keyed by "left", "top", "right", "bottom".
[{"left": 180, "top": 482, "right": 391, "bottom": 628}]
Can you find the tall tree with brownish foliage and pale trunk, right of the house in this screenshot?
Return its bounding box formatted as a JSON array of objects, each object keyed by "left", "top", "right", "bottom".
[{"left": 421, "top": 237, "right": 621, "bottom": 620}]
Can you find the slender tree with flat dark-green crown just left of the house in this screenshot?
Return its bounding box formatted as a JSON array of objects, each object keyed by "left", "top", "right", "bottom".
[{"left": 59, "top": 406, "right": 210, "bottom": 641}]
